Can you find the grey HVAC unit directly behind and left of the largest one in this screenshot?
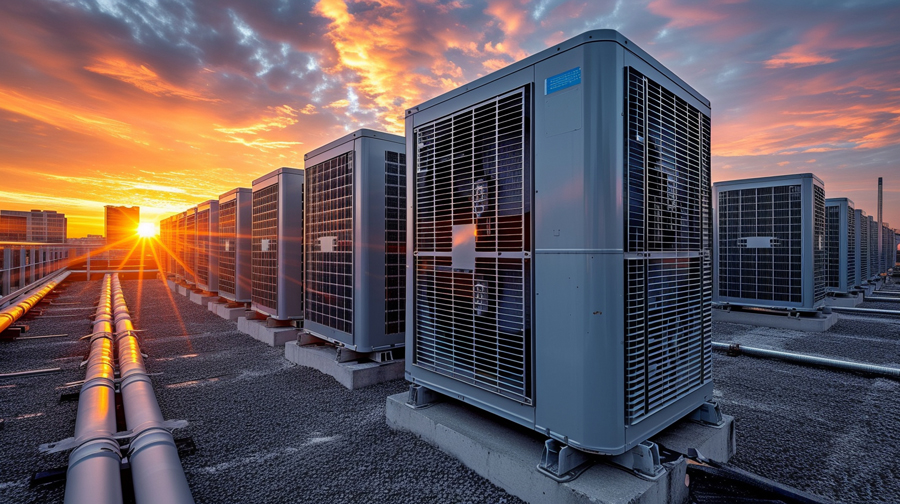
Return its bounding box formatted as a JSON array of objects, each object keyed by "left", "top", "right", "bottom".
[{"left": 303, "top": 129, "right": 406, "bottom": 353}]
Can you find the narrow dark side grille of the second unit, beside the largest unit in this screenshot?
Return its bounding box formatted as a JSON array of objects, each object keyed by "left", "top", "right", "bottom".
[{"left": 384, "top": 151, "right": 406, "bottom": 334}]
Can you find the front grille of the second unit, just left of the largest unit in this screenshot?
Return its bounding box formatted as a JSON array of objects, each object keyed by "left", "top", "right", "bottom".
[{"left": 304, "top": 151, "right": 354, "bottom": 334}]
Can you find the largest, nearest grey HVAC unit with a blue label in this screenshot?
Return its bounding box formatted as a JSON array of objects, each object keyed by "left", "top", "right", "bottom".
[{"left": 406, "top": 30, "right": 713, "bottom": 466}]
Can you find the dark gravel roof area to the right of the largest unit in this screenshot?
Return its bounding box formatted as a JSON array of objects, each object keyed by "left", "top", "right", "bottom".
[{"left": 713, "top": 285, "right": 900, "bottom": 503}]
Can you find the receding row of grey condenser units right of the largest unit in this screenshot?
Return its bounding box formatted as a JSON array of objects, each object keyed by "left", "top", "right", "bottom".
[{"left": 713, "top": 173, "right": 897, "bottom": 311}]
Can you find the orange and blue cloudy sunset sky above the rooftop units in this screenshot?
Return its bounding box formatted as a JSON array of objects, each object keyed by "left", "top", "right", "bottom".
[{"left": 0, "top": 0, "right": 900, "bottom": 237}]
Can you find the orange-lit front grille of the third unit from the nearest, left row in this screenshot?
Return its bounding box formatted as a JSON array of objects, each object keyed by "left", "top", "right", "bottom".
[{"left": 250, "top": 183, "right": 278, "bottom": 310}]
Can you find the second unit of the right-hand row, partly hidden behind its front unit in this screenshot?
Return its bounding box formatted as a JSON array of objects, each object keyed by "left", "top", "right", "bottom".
[{"left": 825, "top": 198, "right": 856, "bottom": 294}]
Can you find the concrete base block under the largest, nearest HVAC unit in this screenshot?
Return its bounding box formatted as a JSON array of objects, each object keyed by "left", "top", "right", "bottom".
[{"left": 385, "top": 392, "right": 734, "bottom": 504}]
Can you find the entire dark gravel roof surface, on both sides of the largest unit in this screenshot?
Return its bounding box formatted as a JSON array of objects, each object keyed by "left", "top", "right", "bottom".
[{"left": 0, "top": 280, "right": 900, "bottom": 503}]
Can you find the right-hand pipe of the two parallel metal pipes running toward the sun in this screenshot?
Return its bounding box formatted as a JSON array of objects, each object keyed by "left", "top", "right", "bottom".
[{"left": 112, "top": 274, "right": 194, "bottom": 504}]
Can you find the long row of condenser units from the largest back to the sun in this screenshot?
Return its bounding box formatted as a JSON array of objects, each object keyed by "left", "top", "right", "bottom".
[{"left": 153, "top": 30, "right": 884, "bottom": 460}]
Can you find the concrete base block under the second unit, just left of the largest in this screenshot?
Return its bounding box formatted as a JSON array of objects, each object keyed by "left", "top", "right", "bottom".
[{"left": 284, "top": 340, "right": 406, "bottom": 390}]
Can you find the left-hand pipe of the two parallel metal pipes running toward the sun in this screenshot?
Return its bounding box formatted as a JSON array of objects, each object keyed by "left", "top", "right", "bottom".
[{"left": 65, "top": 275, "right": 122, "bottom": 504}]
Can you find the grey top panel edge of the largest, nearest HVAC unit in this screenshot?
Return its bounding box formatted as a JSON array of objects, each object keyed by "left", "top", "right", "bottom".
[{"left": 406, "top": 30, "right": 710, "bottom": 117}]
